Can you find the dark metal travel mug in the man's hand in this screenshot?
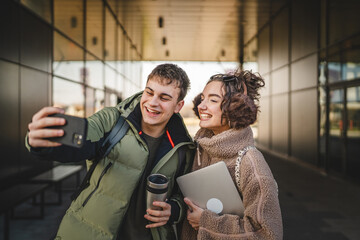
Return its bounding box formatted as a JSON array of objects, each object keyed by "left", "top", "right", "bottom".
[{"left": 146, "top": 173, "right": 169, "bottom": 210}]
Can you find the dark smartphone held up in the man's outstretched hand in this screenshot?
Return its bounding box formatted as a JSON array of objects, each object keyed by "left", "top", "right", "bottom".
[{"left": 48, "top": 113, "right": 87, "bottom": 148}]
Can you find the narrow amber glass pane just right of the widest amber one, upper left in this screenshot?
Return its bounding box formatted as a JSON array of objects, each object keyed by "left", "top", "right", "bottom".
[{"left": 86, "top": 0, "right": 103, "bottom": 59}]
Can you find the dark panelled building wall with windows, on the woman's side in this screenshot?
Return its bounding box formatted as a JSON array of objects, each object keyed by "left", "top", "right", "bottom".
[{"left": 244, "top": 0, "right": 360, "bottom": 181}]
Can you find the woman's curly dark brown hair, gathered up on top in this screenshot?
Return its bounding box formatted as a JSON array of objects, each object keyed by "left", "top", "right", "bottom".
[{"left": 193, "top": 70, "right": 265, "bottom": 129}]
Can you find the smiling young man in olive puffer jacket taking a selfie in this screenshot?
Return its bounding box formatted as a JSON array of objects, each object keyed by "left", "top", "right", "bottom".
[{"left": 26, "top": 64, "right": 194, "bottom": 240}]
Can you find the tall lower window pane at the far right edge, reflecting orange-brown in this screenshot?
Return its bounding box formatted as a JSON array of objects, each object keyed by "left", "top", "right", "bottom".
[{"left": 346, "top": 87, "right": 360, "bottom": 179}]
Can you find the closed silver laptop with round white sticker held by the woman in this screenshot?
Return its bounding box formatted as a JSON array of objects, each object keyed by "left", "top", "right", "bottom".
[{"left": 176, "top": 161, "right": 244, "bottom": 216}]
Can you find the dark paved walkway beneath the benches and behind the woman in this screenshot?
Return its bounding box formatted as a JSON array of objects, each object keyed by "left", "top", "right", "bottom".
[{"left": 0, "top": 153, "right": 360, "bottom": 240}]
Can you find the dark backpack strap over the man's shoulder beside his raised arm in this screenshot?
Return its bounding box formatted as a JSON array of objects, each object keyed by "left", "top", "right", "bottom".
[{"left": 71, "top": 115, "right": 129, "bottom": 200}]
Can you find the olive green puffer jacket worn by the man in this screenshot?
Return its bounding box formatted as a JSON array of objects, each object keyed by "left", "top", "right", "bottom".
[{"left": 27, "top": 93, "right": 194, "bottom": 240}]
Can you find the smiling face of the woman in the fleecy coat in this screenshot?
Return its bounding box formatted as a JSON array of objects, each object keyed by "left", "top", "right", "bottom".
[{"left": 198, "top": 81, "right": 230, "bottom": 134}]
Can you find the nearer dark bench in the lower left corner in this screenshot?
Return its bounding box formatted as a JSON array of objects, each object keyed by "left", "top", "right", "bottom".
[{"left": 0, "top": 183, "right": 49, "bottom": 240}]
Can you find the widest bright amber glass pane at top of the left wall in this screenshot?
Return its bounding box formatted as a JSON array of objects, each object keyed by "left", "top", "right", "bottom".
[{"left": 54, "top": 0, "right": 84, "bottom": 45}]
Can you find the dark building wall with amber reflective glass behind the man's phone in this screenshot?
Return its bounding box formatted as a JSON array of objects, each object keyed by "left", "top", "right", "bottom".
[{"left": 0, "top": 0, "right": 142, "bottom": 188}]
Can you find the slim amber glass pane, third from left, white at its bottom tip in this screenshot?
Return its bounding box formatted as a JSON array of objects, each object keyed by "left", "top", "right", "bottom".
[{"left": 104, "top": 8, "right": 116, "bottom": 68}]
